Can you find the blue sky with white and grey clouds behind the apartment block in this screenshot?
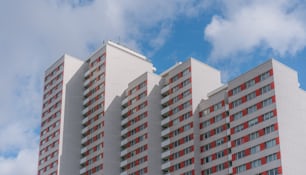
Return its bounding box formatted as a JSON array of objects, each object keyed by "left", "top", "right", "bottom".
[{"left": 0, "top": 0, "right": 306, "bottom": 175}]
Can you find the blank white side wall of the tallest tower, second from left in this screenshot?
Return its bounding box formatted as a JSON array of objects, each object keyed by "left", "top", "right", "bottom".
[{"left": 103, "top": 43, "right": 153, "bottom": 174}]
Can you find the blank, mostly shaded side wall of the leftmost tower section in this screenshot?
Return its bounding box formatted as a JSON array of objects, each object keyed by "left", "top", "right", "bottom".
[{"left": 59, "top": 55, "right": 84, "bottom": 175}]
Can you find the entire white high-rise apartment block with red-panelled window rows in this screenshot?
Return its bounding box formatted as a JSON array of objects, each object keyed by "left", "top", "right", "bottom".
[{"left": 38, "top": 41, "right": 306, "bottom": 175}]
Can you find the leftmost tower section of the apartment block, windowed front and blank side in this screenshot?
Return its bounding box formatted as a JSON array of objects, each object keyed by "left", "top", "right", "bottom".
[{"left": 38, "top": 55, "right": 83, "bottom": 175}]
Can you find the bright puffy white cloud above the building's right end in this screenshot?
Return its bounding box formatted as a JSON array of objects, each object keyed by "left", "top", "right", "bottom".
[{"left": 204, "top": 0, "right": 306, "bottom": 61}]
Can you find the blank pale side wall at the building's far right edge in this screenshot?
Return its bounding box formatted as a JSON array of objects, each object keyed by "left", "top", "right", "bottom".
[{"left": 273, "top": 60, "right": 306, "bottom": 175}]
